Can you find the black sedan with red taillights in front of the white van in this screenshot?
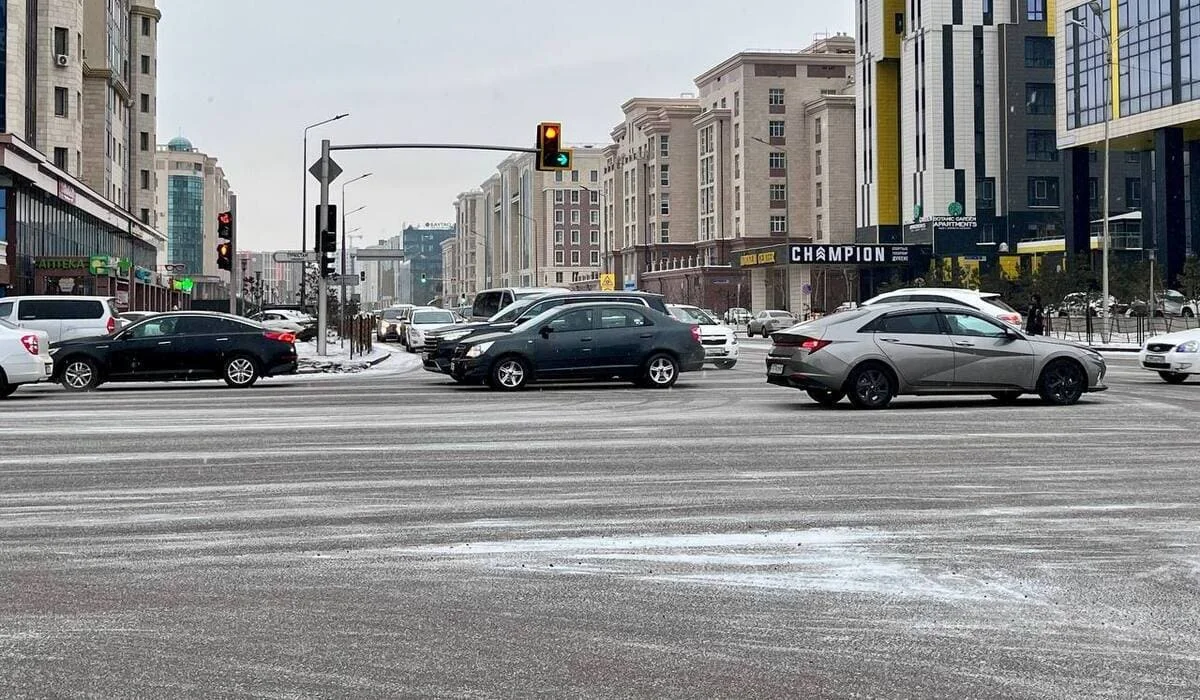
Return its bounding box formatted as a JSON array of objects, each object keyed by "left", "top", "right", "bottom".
[{"left": 50, "top": 311, "right": 296, "bottom": 391}]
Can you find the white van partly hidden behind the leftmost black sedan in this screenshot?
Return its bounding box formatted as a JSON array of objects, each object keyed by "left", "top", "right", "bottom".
[{"left": 0, "top": 295, "right": 120, "bottom": 342}]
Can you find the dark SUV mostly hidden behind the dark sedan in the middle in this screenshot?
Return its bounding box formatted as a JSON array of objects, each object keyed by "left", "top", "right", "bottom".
[{"left": 424, "top": 289, "right": 667, "bottom": 373}]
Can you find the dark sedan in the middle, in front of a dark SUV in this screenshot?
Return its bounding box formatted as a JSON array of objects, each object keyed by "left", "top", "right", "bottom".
[{"left": 450, "top": 303, "right": 704, "bottom": 391}]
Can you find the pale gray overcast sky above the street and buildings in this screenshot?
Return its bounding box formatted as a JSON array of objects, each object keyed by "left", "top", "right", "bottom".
[{"left": 158, "top": 0, "right": 854, "bottom": 250}]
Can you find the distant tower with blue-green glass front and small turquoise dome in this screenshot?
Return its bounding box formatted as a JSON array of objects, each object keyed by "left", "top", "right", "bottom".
[{"left": 155, "top": 136, "right": 230, "bottom": 281}]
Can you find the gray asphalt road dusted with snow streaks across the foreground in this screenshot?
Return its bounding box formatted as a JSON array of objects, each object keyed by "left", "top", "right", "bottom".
[{"left": 0, "top": 343, "right": 1200, "bottom": 698}]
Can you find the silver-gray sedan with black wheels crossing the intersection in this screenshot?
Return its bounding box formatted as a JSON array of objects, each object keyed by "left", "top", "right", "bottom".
[{"left": 767, "top": 304, "right": 1106, "bottom": 408}]
